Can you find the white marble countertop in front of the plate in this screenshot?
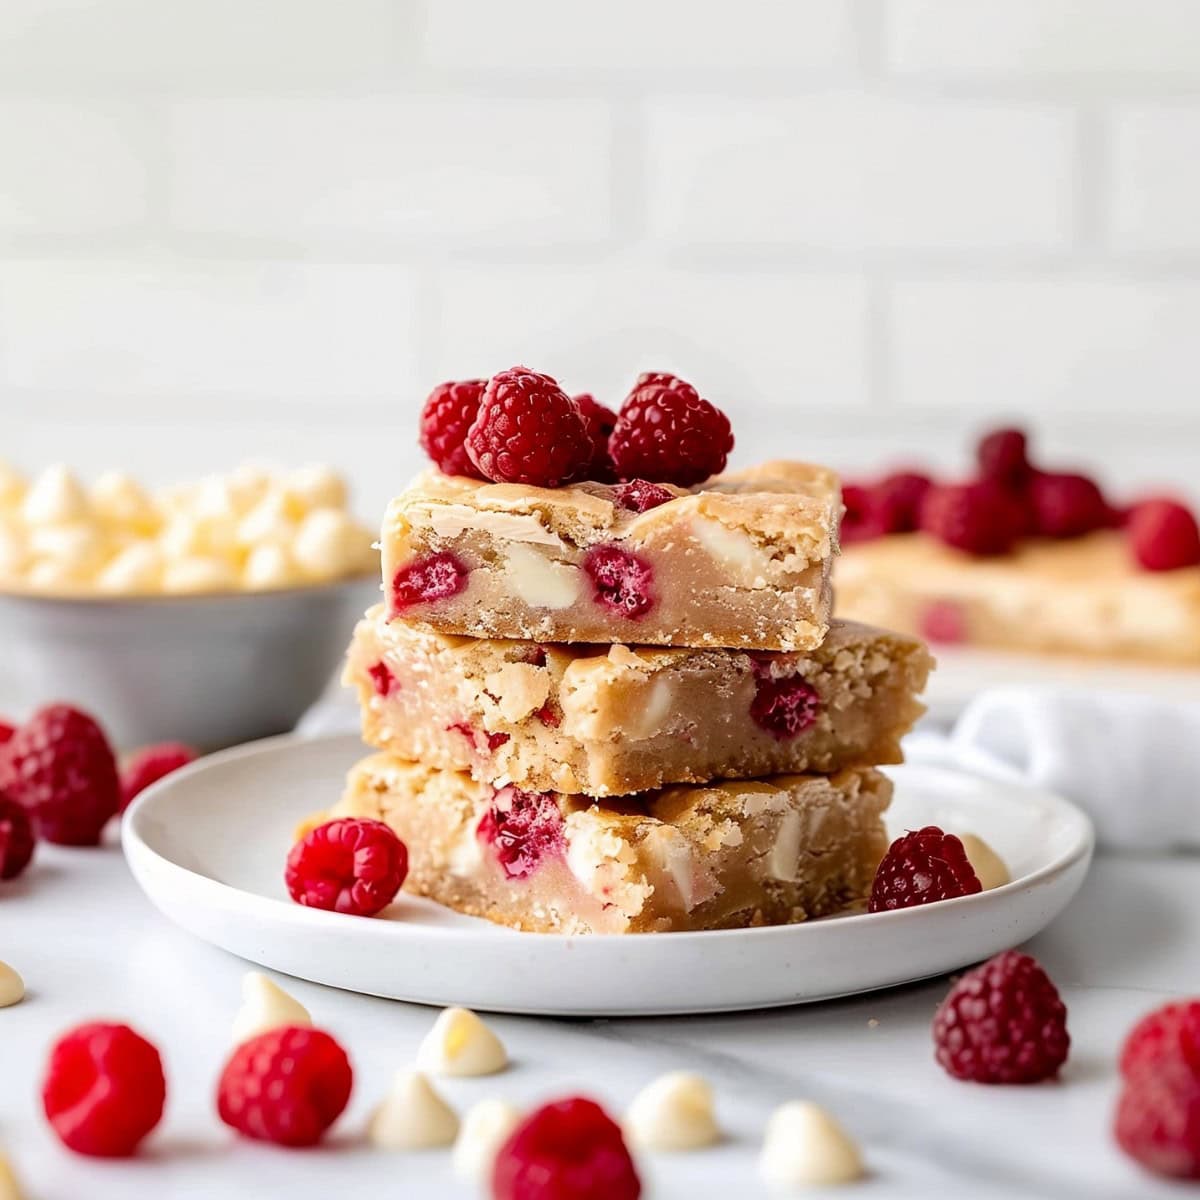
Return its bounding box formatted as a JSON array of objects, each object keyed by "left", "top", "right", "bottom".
[{"left": 0, "top": 847, "right": 1200, "bottom": 1200}]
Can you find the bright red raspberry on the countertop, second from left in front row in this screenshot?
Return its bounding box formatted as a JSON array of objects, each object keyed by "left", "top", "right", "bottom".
[{"left": 217, "top": 1025, "right": 354, "bottom": 1146}]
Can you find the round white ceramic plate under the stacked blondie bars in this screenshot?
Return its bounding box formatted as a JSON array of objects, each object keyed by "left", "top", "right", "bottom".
[{"left": 124, "top": 736, "right": 1092, "bottom": 1016}]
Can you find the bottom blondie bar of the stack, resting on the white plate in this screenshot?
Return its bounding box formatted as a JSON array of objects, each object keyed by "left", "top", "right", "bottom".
[{"left": 330, "top": 754, "right": 892, "bottom": 934}]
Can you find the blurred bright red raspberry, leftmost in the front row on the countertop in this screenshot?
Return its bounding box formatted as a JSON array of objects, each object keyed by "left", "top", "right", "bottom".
[{"left": 42, "top": 1021, "right": 167, "bottom": 1158}]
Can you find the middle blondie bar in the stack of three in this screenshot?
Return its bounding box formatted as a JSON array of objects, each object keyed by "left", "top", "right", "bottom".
[{"left": 344, "top": 606, "right": 932, "bottom": 796}]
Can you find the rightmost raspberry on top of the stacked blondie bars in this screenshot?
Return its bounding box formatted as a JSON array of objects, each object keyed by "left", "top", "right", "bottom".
[{"left": 608, "top": 374, "right": 733, "bottom": 487}]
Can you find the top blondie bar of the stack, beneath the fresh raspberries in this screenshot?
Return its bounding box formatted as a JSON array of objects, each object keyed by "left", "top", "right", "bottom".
[{"left": 382, "top": 462, "right": 841, "bottom": 650}]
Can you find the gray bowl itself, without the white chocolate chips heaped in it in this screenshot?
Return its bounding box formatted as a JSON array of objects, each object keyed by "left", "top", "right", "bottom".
[{"left": 0, "top": 576, "right": 379, "bottom": 750}]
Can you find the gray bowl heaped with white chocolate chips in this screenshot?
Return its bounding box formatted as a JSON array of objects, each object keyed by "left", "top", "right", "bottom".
[{"left": 0, "top": 464, "right": 379, "bottom": 750}]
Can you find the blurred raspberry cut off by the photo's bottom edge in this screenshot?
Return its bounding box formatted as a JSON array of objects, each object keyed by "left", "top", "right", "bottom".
[{"left": 492, "top": 1096, "right": 642, "bottom": 1200}]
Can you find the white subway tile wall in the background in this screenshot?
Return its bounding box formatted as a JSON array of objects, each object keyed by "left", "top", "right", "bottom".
[{"left": 0, "top": 0, "right": 1200, "bottom": 512}]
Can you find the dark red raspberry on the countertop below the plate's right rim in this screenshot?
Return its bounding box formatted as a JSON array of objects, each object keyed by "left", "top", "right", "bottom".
[{"left": 934, "top": 950, "right": 1070, "bottom": 1084}]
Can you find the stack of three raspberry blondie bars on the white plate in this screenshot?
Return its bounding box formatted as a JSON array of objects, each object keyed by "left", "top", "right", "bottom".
[{"left": 334, "top": 462, "right": 931, "bottom": 934}]
